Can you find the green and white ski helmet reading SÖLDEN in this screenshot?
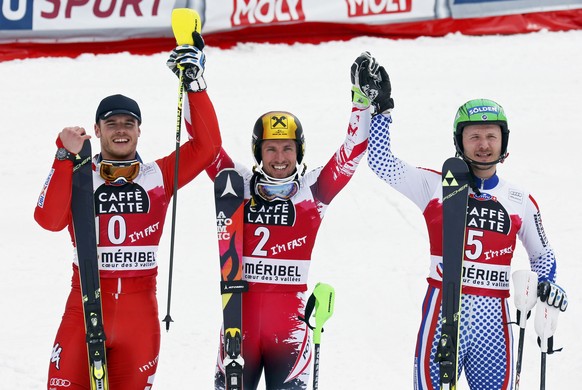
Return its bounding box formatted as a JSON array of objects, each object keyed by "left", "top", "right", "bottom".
[{"left": 453, "top": 99, "right": 509, "bottom": 163}]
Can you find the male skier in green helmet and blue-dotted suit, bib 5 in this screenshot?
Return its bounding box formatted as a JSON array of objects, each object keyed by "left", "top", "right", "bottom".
[{"left": 368, "top": 52, "right": 567, "bottom": 390}]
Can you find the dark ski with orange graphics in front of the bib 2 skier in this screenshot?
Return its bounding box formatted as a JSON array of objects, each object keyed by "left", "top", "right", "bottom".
[{"left": 214, "top": 169, "right": 247, "bottom": 390}]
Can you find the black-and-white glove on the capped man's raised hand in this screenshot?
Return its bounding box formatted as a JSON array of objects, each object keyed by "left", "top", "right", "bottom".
[{"left": 166, "top": 32, "right": 206, "bottom": 92}]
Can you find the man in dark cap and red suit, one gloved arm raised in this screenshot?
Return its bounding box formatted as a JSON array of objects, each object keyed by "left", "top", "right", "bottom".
[{"left": 34, "top": 35, "right": 222, "bottom": 390}]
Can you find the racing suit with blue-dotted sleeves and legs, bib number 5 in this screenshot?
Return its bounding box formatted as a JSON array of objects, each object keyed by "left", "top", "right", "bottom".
[{"left": 368, "top": 115, "right": 556, "bottom": 390}]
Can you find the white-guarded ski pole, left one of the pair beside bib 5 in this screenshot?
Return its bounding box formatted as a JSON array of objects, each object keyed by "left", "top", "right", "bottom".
[{"left": 512, "top": 270, "right": 538, "bottom": 390}]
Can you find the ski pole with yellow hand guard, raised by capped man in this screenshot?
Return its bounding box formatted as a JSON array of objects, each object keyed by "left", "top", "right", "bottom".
[{"left": 163, "top": 8, "right": 200, "bottom": 332}]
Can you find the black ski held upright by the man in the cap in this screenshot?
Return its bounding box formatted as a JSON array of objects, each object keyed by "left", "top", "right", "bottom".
[{"left": 71, "top": 140, "right": 109, "bottom": 390}]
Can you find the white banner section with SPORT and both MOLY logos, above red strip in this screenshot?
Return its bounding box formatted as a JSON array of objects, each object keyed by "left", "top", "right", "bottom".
[{"left": 0, "top": 0, "right": 443, "bottom": 42}]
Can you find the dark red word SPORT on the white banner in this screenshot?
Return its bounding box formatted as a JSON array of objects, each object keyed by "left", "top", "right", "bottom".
[{"left": 40, "top": 0, "right": 160, "bottom": 19}]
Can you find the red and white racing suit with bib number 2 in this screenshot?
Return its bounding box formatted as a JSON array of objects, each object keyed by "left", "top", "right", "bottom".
[{"left": 207, "top": 107, "right": 370, "bottom": 390}]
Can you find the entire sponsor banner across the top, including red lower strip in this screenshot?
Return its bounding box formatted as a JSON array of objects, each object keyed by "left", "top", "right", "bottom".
[{"left": 0, "top": 0, "right": 582, "bottom": 61}]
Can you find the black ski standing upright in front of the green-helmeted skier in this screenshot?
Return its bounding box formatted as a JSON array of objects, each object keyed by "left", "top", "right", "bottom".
[{"left": 436, "top": 157, "right": 470, "bottom": 390}]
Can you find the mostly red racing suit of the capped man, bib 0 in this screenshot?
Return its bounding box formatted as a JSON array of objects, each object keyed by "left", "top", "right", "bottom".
[{"left": 34, "top": 92, "right": 222, "bottom": 390}]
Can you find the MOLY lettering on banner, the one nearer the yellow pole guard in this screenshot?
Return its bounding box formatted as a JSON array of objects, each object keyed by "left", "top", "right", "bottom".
[{"left": 230, "top": 0, "right": 305, "bottom": 26}]
